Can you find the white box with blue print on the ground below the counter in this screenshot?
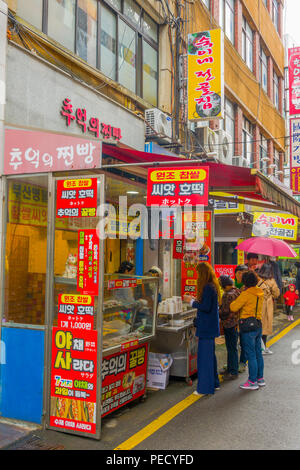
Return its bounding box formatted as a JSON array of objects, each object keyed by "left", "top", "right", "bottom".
[{"left": 147, "top": 352, "right": 173, "bottom": 390}]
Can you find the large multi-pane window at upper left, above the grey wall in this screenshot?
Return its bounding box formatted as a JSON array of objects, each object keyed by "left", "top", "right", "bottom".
[{"left": 17, "top": 0, "right": 158, "bottom": 106}]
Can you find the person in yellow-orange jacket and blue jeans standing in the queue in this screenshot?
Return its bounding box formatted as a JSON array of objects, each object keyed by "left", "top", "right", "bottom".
[{"left": 230, "top": 271, "right": 266, "bottom": 390}]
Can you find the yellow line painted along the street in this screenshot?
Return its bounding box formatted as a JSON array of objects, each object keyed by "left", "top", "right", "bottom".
[{"left": 114, "top": 319, "right": 300, "bottom": 450}]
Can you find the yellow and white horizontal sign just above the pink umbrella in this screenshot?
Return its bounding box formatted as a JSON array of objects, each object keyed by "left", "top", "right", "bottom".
[{"left": 252, "top": 212, "right": 298, "bottom": 240}]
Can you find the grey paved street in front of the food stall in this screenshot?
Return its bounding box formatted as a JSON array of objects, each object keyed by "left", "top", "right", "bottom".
[{"left": 5, "top": 318, "right": 300, "bottom": 450}]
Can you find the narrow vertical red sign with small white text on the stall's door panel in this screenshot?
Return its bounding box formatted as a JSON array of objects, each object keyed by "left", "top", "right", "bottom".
[{"left": 77, "top": 229, "right": 99, "bottom": 295}]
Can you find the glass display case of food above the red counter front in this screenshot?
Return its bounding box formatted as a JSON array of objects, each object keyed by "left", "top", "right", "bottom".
[{"left": 103, "top": 274, "right": 158, "bottom": 355}]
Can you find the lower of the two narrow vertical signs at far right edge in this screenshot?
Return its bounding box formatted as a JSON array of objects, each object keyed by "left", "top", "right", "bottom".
[{"left": 290, "top": 117, "right": 300, "bottom": 193}]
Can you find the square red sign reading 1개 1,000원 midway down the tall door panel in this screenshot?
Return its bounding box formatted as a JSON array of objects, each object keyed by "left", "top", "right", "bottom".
[{"left": 57, "top": 294, "right": 94, "bottom": 331}]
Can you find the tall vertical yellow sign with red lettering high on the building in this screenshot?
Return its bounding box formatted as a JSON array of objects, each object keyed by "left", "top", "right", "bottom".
[{"left": 188, "top": 29, "right": 224, "bottom": 121}]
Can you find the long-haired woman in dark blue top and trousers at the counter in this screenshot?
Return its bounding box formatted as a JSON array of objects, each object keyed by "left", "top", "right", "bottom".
[{"left": 184, "top": 263, "right": 221, "bottom": 395}]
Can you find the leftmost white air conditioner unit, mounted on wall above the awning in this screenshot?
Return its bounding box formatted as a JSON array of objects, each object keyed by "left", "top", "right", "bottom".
[{"left": 145, "top": 108, "right": 172, "bottom": 142}]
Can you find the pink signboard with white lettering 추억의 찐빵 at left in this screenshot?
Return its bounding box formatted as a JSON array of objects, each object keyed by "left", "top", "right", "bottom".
[{"left": 4, "top": 129, "right": 102, "bottom": 175}]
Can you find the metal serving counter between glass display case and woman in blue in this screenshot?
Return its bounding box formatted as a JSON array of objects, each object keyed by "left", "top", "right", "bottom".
[{"left": 151, "top": 305, "right": 198, "bottom": 385}]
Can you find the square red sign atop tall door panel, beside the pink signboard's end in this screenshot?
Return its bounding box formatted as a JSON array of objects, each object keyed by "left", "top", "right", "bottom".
[{"left": 56, "top": 178, "right": 97, "bottom": 218}]
